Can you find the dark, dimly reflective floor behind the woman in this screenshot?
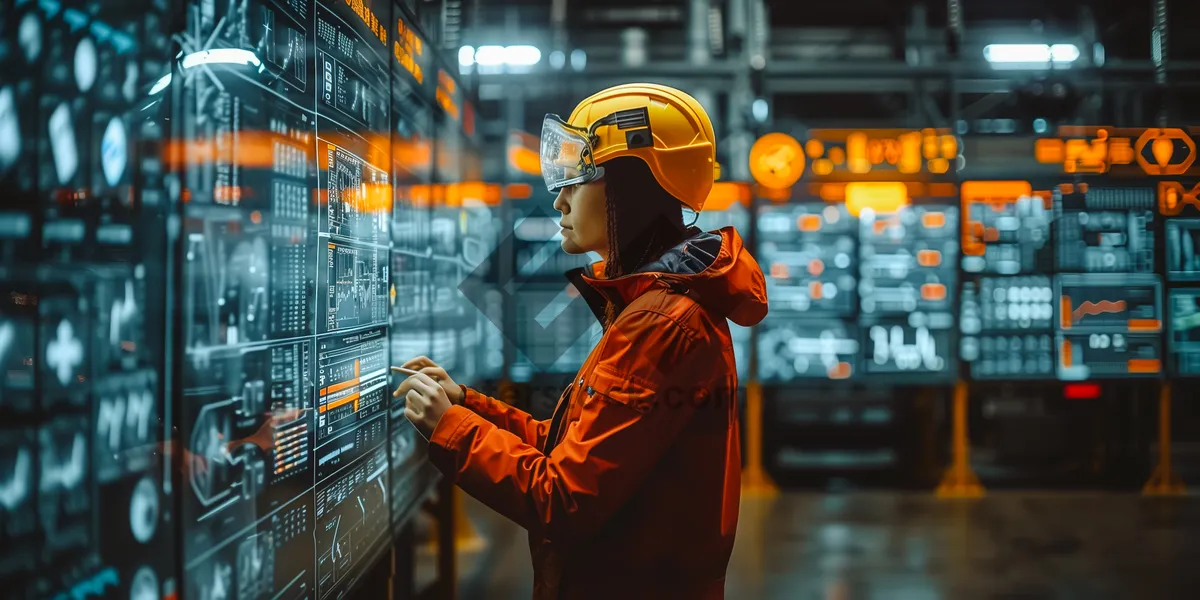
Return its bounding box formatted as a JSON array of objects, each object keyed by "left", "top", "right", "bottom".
[{"left": 422, "top": 492, "right": 1200, "bottom": 600}]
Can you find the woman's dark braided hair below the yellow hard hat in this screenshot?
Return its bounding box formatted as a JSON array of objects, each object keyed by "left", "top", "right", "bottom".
[{"left": 604, "top": 156, "right": 686, "bottom": 326}]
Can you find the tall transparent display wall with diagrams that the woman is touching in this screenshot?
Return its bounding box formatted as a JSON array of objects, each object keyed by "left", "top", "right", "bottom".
[{"left": 172, "top": 0, "right": 446, "bottom": 600}]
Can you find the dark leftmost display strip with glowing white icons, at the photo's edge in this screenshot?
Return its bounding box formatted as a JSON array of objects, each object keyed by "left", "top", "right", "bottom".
[{"left": 0, "top": 1, "right": 179, "bottom": 599}]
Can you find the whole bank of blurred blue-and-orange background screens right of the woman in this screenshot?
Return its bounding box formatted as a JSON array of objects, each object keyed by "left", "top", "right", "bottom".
[{"left": 756, "top": 176, "right": 1200, "bottom": 384}]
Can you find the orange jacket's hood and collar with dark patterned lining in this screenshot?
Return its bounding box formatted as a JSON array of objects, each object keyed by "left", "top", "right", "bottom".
[{"left": 566, "top": 227, "right": 767, "bottom": 326}]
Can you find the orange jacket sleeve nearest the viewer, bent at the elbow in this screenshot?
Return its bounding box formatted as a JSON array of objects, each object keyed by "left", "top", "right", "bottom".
[{"left": 430, "top": 311, "right": 704, "bottom": 542}]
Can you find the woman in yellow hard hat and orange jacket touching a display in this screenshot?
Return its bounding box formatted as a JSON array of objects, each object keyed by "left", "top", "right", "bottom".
[{"left": 394, "top": 84, "right": 767, "bottom": 600}]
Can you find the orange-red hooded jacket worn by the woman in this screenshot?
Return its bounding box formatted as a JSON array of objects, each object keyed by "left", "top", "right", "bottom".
[{"left": 430, "top": 227, "right": 767, "bottom": 600}]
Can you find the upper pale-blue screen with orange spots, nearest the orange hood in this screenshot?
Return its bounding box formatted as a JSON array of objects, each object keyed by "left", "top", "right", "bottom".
[{"left": 756, "top": 203, "right": 858, "bottom": 317}]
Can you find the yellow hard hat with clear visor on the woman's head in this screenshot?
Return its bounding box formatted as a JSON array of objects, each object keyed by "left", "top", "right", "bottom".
[{"left": 541, "top": 83, "right": 721, "bottom": 212}]
